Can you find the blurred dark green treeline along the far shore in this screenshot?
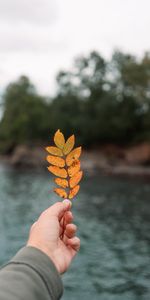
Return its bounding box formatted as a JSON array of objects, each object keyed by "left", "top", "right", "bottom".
[{"left": 0, "top": 52, "right": 150, "bottom": 153}]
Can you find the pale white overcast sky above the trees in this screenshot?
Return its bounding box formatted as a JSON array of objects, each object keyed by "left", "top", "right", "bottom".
[{"left": 0, "top": 0, "right": 150, "bottom": 95}]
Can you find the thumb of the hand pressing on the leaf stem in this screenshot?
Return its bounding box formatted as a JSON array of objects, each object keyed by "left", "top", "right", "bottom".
[{"left": 47, "top": 199, "right": 72, "bottom": 219}]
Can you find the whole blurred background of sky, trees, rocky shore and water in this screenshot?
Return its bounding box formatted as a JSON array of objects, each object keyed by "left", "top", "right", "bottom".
[{"left": 0, "top": 0, "right": 150, "bottom": 300}]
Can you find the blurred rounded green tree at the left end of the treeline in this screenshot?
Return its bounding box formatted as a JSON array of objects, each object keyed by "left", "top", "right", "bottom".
[{"left": 0, "top": 76, "right": 49, "bottom": 152}]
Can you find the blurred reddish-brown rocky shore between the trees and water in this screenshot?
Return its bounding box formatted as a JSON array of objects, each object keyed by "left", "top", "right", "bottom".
[{"left": 0, "top": 143, "right": 150, "bottom": 178}]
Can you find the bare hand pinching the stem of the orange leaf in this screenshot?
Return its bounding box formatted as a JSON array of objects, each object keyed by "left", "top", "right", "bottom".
[{"left": 27, "top": 199, "right": 80, "bottom": 273}]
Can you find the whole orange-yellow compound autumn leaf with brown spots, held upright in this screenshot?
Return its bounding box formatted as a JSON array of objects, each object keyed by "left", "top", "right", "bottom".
[{"left": 46, "top": 129, "right": 83, "bottom": 199}]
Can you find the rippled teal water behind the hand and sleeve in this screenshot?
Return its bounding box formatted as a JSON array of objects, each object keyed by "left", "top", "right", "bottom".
[{"left": 0, "top": 166, "right": 150, "bottom": 300}]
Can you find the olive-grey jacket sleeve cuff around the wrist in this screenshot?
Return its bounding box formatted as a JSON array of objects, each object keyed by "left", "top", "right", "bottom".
[{"left": 0, "top": 247, "right": 63, "bottom": 300}]
